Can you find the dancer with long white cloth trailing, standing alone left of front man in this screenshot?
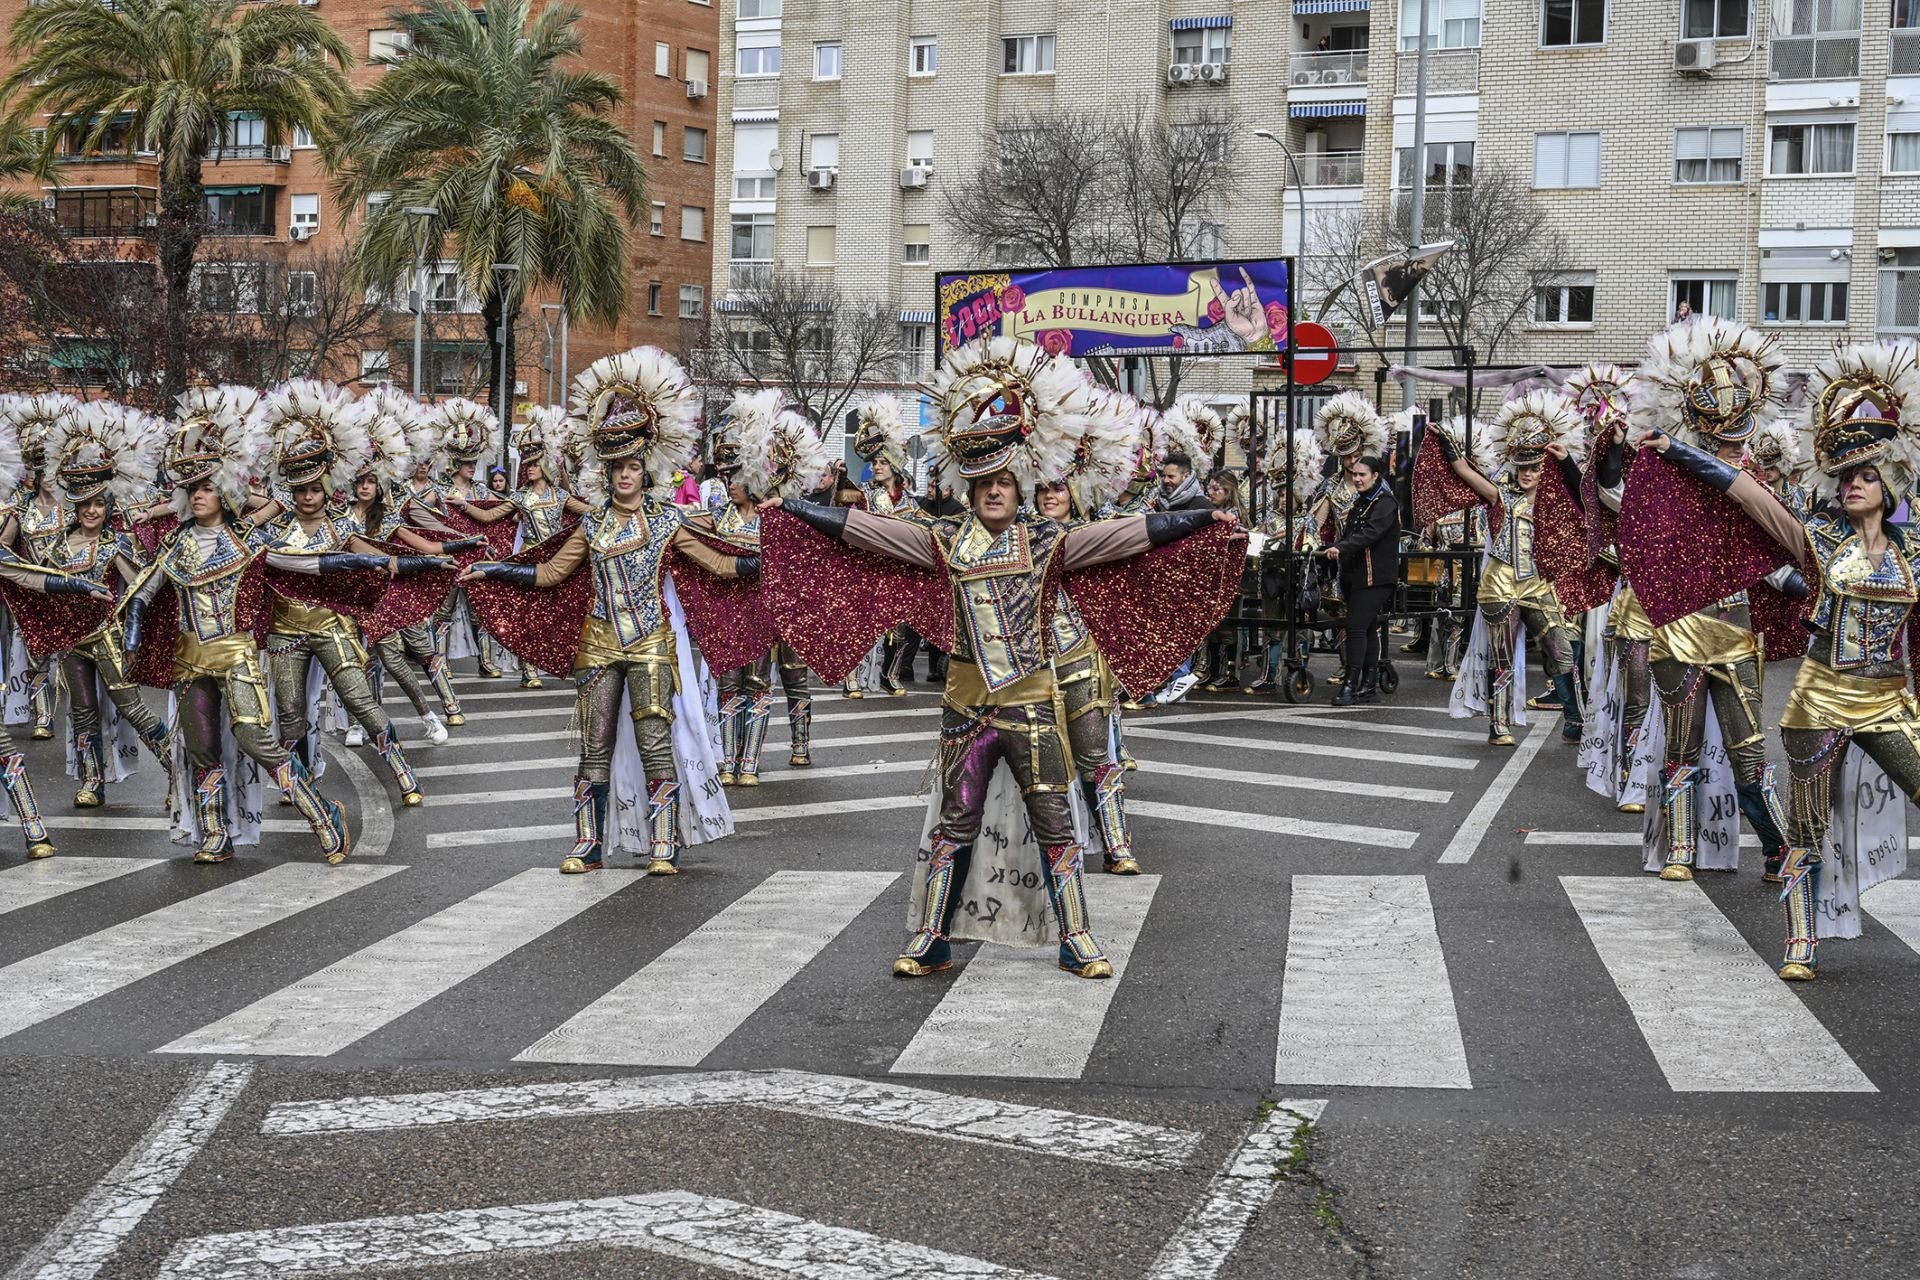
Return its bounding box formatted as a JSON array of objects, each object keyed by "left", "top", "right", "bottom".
[{"left": 461, "top": 347, "right": 758, "bottom": 875}]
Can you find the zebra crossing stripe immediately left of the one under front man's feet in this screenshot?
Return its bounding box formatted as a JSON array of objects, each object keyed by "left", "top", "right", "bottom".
[{"left": 515, "top": 871, "right": 900, "bottom": 1067}]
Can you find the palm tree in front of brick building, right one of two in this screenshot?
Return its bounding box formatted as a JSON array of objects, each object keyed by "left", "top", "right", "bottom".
[{"left": 328, "top": 0, "right": 645, "bottom": 416}]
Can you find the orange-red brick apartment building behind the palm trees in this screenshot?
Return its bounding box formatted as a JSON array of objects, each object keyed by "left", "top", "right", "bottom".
[{"left": 0, "top": 0, "right": 718, "bottom": 399}]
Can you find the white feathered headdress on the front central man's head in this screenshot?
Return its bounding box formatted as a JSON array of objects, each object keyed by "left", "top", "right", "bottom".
[{"left": 922, "top": 336, "right": 1087, "bottom": 491}]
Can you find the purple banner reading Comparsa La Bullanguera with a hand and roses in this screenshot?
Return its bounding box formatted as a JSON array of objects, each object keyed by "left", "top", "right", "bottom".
[{"left": 935, "top": 257, "right": 1292, "bottom": 357}]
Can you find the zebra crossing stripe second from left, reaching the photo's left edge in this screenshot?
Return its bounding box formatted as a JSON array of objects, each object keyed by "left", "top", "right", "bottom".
[{"left": 0, "top": 867, "right": 405, "bottom": 1038}]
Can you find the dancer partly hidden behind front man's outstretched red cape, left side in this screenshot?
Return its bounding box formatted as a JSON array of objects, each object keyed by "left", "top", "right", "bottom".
[{"left": 714, "top": 391, "right": 828, "bottom": 787}]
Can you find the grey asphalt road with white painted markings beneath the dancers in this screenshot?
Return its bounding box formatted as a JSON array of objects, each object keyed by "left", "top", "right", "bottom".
[{"left": 0, "top": 652, "right": 1920, "bottom": 1280}]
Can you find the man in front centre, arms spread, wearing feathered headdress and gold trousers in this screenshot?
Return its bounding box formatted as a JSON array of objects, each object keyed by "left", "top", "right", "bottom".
[{"left": 762, "top": 338, "right": 1242, "bottom": 979}]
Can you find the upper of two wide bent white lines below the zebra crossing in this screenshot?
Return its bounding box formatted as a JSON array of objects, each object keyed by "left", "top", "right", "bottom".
[{"left": 259, "top": 1074, "right": 1200, "bottom": 1171}]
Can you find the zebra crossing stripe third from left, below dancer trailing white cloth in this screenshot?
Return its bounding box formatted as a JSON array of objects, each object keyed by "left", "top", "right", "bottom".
[{"left": 159, "top": 867, "right": 645, "bottom": 1057}]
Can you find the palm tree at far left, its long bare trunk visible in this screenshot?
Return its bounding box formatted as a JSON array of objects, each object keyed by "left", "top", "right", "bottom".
[{"left": 0, "top": 0, "right": 348, "bottom": 395}]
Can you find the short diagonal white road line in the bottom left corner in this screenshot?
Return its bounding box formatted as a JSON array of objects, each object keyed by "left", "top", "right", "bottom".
[{"left": 6, "top": 1063, "right": 253, "bottom": 1280}]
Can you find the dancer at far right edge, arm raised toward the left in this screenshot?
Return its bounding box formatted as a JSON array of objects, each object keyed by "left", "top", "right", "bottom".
[{"left": 1645, "top": 344, "right": 1920, "bottom": 983}]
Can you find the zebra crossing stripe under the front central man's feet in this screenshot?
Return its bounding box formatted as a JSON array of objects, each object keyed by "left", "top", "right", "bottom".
[{"left": 893, "top": 875, "right": 1160, "bottom": 1080}]
